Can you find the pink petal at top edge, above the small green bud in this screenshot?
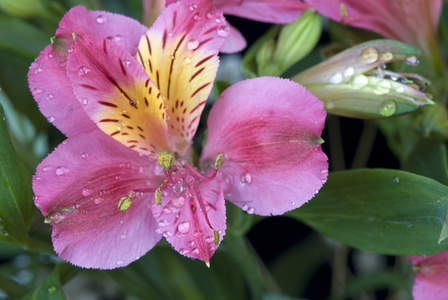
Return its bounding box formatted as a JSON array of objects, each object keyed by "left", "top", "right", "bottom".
[{"left": 213, "top": 0, "right": 309, "bottom": 24}]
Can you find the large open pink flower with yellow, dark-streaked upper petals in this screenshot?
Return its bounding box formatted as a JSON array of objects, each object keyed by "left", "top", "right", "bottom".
[{"left": 29, "top": 0, "right": 328, "bottom": 269}]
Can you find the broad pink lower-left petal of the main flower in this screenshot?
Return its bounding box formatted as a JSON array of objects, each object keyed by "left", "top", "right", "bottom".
[{"left": 33, "top": 131, "right": 163, "bottom": 269}]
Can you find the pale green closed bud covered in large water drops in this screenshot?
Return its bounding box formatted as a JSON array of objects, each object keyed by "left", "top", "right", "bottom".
[{"left": 292, "top": 40, "right": 434, "bottom": 119}]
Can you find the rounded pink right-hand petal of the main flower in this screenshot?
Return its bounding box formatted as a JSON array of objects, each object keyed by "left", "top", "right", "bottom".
[{"left": 201, "top": 77, "right": 328, "bottom": 215}]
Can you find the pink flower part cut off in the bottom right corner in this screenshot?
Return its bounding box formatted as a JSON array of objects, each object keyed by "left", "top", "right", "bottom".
[{"left": 408, "top": 251, "right": 448, "bottom": 300}]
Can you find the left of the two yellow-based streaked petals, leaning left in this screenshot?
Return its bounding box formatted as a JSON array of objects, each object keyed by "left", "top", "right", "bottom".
[{"left": 67, "top": 37, "right": 169, "bottom": 157}]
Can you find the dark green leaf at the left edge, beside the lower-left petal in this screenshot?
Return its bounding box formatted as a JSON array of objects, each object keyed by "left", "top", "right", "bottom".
[{"left": 0, "top": 105, "right": 34, "bottom": 244}]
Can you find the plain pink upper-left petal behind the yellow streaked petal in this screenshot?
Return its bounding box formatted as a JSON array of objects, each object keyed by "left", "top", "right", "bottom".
[{"left": 28, "top": 6, "right": 147, "bottom": 137}]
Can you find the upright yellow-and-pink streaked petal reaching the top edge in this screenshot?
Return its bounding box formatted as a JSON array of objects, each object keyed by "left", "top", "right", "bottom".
[{"left": 137, "top": 0, "right": 229, "bottom": 153}]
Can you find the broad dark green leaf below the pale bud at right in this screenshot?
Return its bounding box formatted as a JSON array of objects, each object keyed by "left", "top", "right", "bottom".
[{"left": 288, "top": 169, "right": 448, "bottom": 255}]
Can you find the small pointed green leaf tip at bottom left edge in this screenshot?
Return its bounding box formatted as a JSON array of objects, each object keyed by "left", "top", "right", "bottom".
[{"left": 23, "top": 265, "right": 65, "bottom": 300}]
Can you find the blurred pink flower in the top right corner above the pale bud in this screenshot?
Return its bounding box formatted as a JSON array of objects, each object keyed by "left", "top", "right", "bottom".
[{"left": 306, "top": 0, "right": 442, "bottom": 58}]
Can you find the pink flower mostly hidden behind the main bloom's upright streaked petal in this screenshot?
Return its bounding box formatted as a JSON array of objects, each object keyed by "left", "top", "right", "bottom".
[{"left": 166, "top": 0, "right": 310, "bottom": 53}]
